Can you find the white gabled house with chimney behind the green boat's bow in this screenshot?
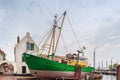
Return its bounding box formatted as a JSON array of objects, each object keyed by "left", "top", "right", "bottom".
[{"left": 14, "top": 32, "right": 39, "bottom": 74}]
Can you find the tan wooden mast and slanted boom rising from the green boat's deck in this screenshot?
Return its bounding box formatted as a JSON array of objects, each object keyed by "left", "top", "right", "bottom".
[{"left": 40, "top": 11, "right": 66, "bottom": 60}]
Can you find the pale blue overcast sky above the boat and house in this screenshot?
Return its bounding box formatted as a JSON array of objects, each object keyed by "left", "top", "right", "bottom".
[{"left": 0, "top": 0, "right": 120, "bottom": 67}]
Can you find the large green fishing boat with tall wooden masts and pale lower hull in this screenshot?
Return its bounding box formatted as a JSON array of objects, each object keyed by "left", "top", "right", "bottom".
[{"left": 23, "top": 12, "right": 94, "bottom": 78}]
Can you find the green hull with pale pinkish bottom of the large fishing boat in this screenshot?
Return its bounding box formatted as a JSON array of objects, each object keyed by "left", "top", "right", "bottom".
[{"left": 23, "top": 53, "right": 94, "bottom": 77}]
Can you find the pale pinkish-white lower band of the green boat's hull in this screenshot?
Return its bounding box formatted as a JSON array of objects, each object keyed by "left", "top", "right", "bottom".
[{"left": 30, "top": 70, "right": 87, "bottom": 78}]
